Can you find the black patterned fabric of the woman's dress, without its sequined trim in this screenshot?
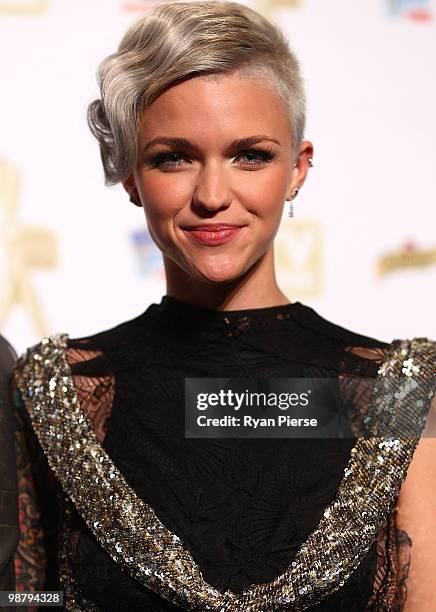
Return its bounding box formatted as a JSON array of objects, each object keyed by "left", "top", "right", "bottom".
[{"left": 13, "top": 295, "right": 430, "bottom": 612}]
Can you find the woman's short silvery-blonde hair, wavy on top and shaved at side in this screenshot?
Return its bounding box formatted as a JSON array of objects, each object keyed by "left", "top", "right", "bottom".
[{"left": 88, "top": 0, "right": 306, "bottom": 185}]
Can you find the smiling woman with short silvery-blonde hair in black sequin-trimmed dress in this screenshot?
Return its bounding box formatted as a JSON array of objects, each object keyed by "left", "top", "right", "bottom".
[{"left": 11, "top": 0, "right": 436, "bottom": 612}]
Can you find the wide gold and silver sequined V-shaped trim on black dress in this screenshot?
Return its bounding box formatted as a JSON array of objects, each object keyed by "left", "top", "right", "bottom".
[{"left": 15, "top": 334, "right": 436, "bottom": 612}]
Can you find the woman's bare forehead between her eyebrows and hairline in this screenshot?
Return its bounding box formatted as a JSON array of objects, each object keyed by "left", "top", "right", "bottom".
[{"left": 140, "top": 74, "right": 290, "bottom": 140}]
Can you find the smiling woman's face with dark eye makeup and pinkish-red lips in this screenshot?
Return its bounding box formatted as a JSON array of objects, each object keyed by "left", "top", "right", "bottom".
[{"left": 124, "top": 73, "right": 312, "bottom": 283}]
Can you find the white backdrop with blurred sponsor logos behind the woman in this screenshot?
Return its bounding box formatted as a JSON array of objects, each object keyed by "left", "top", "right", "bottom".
[{"left": 0, "top": 0, "right": 436, "bottom": 352}]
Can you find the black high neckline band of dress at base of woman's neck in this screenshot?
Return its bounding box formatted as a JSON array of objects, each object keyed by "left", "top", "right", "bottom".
[{"left": 157, "top": 294, "right": 307, "bottom": 320}]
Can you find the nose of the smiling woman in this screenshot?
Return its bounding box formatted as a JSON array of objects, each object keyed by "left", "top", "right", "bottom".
[{"left": 192, "top": 164, "right": 232, "bottom": 212}]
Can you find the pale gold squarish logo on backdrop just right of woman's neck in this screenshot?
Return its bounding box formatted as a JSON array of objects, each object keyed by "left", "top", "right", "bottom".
[{"left": 275, "top": 219, "right": 323, "bottom": 299}]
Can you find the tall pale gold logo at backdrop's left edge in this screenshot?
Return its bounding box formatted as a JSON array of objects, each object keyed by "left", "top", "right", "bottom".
[{"left": 0, "top": 158, "right": 57, "bottom": 336}]
